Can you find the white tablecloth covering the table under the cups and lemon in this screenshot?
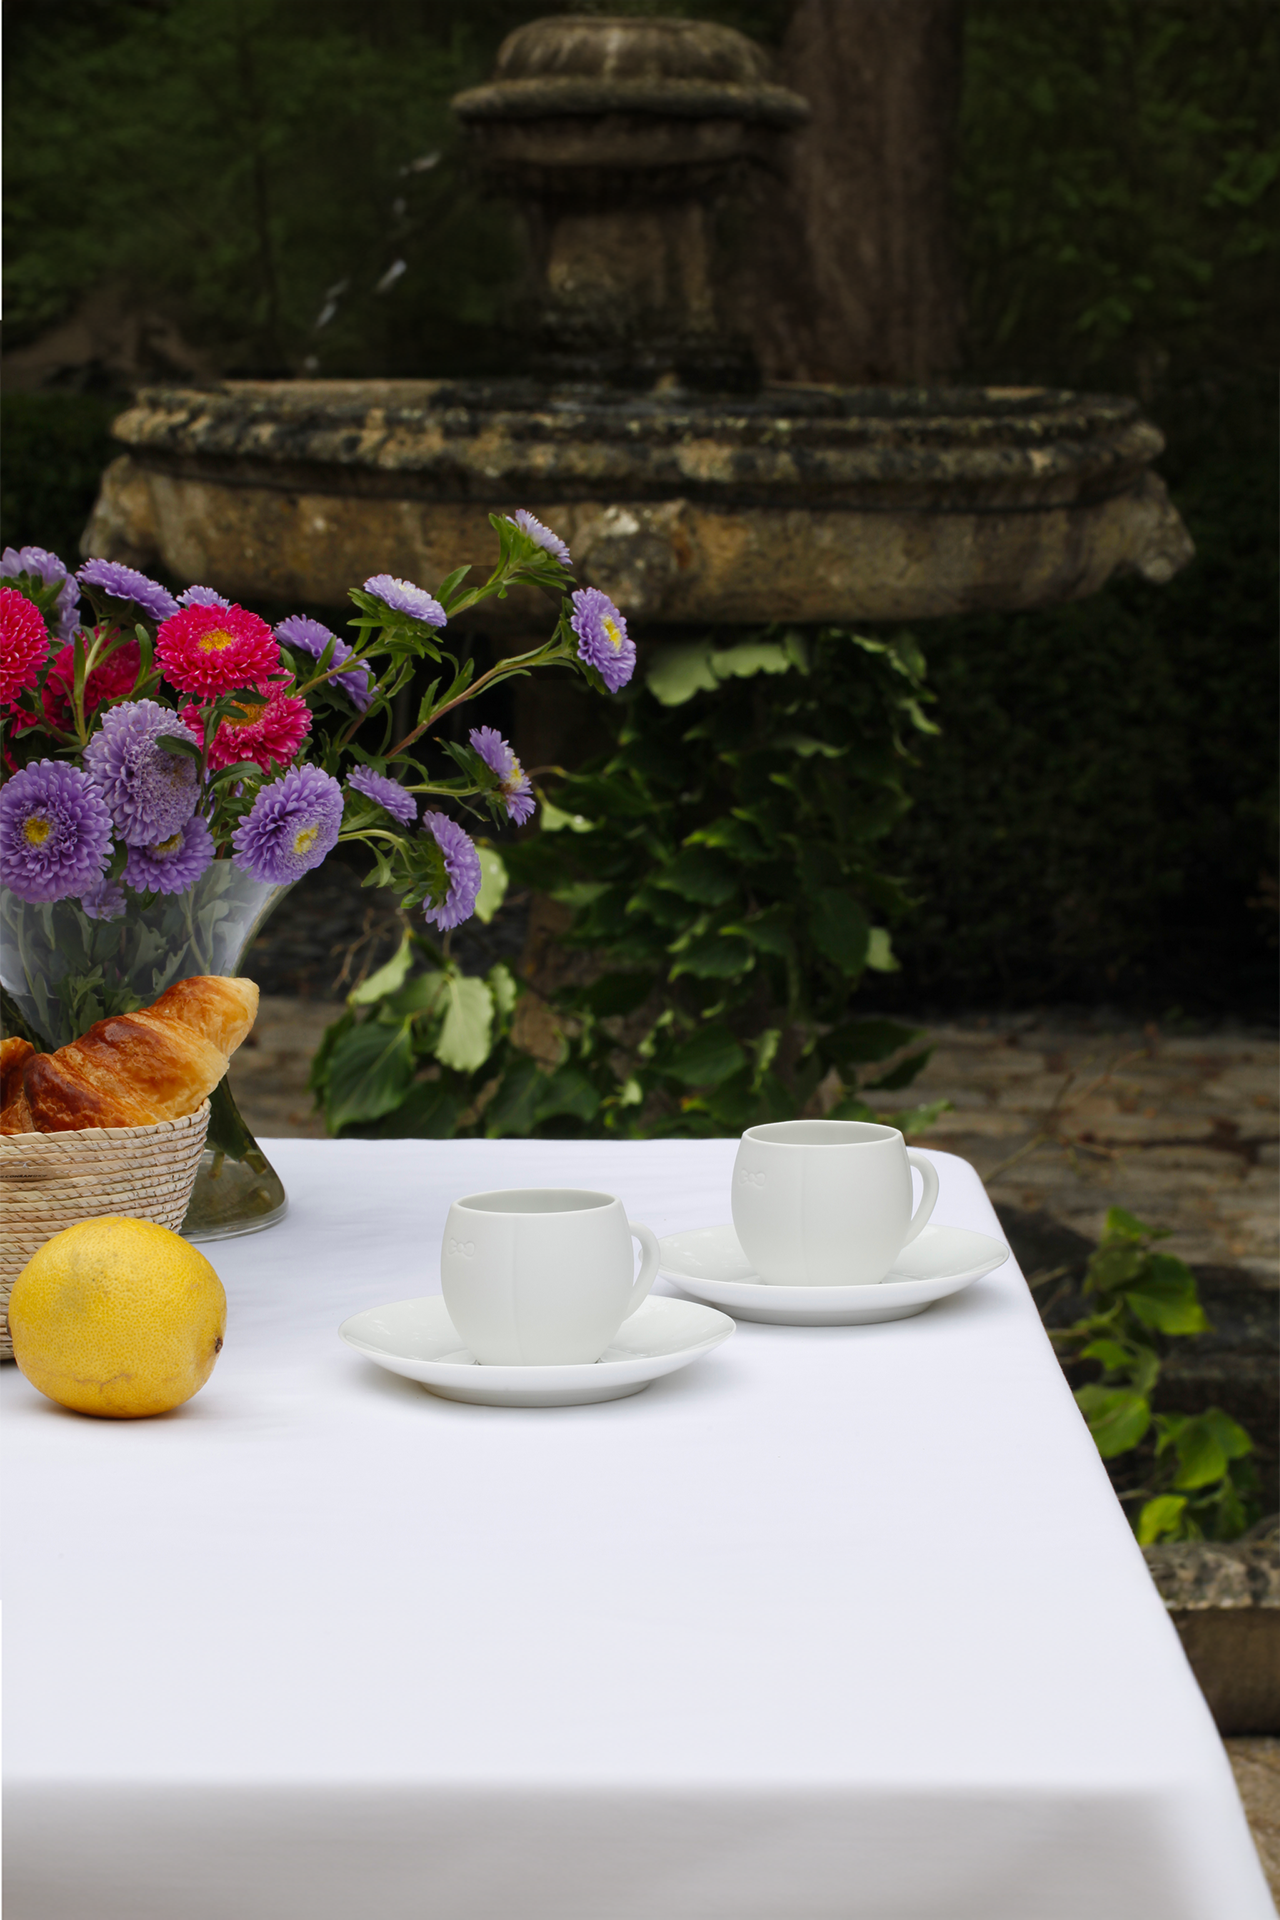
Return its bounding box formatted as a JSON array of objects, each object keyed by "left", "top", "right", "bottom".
[{"left": 2, "top": 1140, "right": 1272, "bottom": 1920}]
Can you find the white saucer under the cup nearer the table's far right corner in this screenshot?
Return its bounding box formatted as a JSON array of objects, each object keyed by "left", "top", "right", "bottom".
[{"left": 658, "top": 1227, "right": 1009, "bottom": 1327}]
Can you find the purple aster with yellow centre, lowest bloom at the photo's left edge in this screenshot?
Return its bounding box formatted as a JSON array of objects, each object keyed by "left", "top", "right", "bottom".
[{"left": 0, "top": 760, "right": 111, "bottom": 900}]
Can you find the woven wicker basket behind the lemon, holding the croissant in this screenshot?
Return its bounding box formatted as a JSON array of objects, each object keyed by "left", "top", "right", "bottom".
[{"left": 0, "top": 1100, "right": 209, "bottom": 1359}]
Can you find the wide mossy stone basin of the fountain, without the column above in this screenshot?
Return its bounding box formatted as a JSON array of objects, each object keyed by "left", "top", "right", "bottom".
[{"left": 84, "top": 380, "right": 1192, "bottom": 630}]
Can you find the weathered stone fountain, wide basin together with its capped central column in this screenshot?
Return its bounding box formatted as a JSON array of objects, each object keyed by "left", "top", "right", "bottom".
[{"left": 84, "top": 15, "right": 1192, "bottom": 632}]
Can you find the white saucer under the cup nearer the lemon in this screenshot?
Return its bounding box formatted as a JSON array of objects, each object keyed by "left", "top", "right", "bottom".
[{"left": 338, "top": 1294, "right": 733, "bottom": 1407}]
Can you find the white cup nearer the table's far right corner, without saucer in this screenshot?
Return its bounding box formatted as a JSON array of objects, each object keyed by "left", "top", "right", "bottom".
[{"left": 733, "top": 1119, "right": 938, "bottom": 1286}]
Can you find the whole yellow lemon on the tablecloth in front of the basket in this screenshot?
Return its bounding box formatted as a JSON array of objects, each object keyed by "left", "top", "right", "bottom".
[{"left": 10, "top": 1213, "right": 226, "bottom": 1421}]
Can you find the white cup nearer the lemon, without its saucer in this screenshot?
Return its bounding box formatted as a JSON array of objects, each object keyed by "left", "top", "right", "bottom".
[{"left": 439, "top": 1187, "right": 658, "bottom": 1367}]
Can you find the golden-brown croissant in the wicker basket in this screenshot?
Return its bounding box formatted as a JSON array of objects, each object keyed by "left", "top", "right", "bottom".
[{"left": 0, "top": 973, "right": 257, "bottom": 1133}]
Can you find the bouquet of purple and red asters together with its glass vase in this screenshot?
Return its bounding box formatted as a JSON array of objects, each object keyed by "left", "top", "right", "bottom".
[{"left": 0, "top": 511, "right": 635, "bottom": 1236}]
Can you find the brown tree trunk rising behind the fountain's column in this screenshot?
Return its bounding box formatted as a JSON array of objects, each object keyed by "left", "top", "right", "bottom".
[{"left": 737, "top": 0, "right": 963, "bottom": 384}]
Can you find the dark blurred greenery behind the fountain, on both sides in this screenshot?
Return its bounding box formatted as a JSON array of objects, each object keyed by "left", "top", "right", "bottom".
[{"left": 0, "top": 0, "right": 1280, "bottom": 1018}]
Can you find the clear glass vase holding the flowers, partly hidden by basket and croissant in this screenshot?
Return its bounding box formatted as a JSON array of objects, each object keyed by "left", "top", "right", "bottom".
[{"left": 0, "top": 860, "right": 290, "bottom": 1240}]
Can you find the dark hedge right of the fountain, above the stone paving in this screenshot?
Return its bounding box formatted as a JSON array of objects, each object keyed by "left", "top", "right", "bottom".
[{"left": 887, "top": 380, "right": 1276, "bottom": 1020}]
